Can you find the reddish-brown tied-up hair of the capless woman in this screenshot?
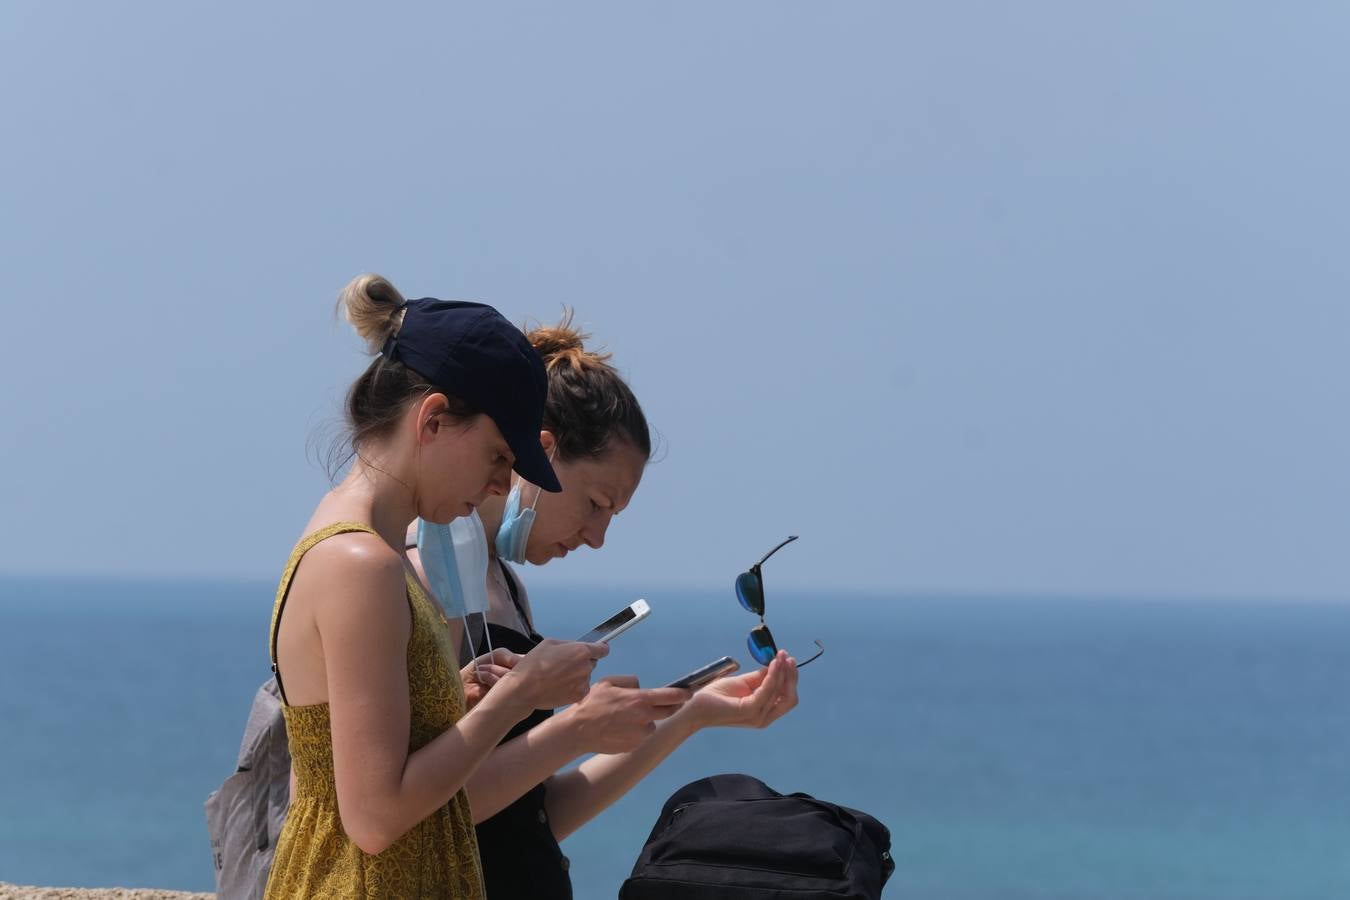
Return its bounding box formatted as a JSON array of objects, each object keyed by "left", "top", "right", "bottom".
[{"left": 525, "top": 310, "right": 652, "bottom": 459}]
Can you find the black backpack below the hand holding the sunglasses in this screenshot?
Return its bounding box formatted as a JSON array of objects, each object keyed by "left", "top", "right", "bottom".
[{"left": 618, "top": 775, "right": 895, "bottom": 900}]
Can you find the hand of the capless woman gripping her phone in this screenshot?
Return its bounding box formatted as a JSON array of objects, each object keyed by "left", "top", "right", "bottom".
[{"left": 563, "top": 675, "right": 690, "bottom": 753}]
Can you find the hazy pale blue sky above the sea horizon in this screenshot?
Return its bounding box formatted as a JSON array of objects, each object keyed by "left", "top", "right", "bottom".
[{"left": 0, "top": 0, "right": 1350, "bottom": 596}]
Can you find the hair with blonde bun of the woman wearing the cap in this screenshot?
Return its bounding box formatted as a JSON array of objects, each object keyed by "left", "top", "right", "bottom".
[{"left": 328, "top": 274, "right": 478, "bottom": 475}]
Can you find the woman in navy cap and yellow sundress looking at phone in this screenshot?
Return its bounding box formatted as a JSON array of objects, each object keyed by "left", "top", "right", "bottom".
[{"left": 266, "top": 275, "right": 608, "bottom": 900}]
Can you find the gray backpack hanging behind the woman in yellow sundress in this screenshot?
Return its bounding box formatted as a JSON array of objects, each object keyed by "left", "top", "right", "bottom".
[{"left": 207, "top": 679, "right": 290, "bottom": 900}]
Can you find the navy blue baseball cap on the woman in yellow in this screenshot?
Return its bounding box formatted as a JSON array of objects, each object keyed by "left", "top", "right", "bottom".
[{"left": 381, "top": 297, "right": 563, "bottom": 494}]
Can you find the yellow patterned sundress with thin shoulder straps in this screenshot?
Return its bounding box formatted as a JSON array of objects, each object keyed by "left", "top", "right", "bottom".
[{"left": 266, "top": 522, "right": 486, "bottom": 900}]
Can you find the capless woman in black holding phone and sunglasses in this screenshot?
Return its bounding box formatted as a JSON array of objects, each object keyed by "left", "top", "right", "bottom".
[{"left": 410, "top": 318, "right": 797, "bottom": 900}]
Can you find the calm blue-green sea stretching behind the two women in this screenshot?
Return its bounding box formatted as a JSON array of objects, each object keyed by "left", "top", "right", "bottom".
[{"left": 0, "top": 576, "right": 1350, "bottom": 900}]
